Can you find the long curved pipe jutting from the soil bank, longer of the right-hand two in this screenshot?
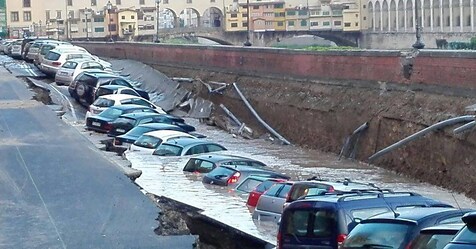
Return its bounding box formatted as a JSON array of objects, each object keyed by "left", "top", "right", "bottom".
[{"left": 369, "top": 115, "right": 476, "bottom": 162}]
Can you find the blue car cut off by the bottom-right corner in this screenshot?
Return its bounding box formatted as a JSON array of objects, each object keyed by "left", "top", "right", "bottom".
[{"left": 444, "top": 212, "right": 476, "bottom": 249}]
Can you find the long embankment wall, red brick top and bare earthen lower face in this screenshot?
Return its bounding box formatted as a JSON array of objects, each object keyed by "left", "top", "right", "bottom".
[{"left": 80, "top": 43, "right": 476, "bottom": 197}]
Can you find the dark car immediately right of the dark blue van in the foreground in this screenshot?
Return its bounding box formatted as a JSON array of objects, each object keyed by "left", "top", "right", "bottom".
[{"left": 342, "top": 207, "right": 470, "bottom": 249}]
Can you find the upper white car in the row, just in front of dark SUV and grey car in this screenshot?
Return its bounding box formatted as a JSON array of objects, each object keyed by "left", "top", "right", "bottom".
[{"left": 86, "top": 94, "right": 166, "bottom": 118}]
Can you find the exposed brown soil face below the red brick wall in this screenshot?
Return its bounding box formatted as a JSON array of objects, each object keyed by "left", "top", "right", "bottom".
[{"left": 151, "top": 67, "right": 476, "bottom": 198}]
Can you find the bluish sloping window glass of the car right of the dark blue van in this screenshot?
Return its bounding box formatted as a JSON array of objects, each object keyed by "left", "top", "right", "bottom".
[{"left": 343, "top": 222, "right": 411, "bottom": 249}]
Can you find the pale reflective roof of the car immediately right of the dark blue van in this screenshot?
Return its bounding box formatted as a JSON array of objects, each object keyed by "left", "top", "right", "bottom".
[{"left": 366, "top": 207, "right": 469, "bottom": 222}]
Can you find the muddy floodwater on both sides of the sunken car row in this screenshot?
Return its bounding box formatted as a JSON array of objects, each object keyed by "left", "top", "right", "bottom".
[{"left": 126, "top": 119, "right": 476, "bottom": 243}]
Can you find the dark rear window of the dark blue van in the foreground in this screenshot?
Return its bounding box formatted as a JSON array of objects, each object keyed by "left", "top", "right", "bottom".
[{"left": 282, "top": 209, "right": 336, "bottom": 238}]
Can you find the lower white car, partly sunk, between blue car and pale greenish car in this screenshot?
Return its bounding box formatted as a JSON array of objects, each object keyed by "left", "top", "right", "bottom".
[{"left": 129, "top": 130, "right": 198, "bottom": 155}]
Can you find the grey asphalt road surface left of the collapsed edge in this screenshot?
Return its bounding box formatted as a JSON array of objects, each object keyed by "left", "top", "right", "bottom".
[{"left": 0, "top": 68, "right": 193, "bottom": 248}]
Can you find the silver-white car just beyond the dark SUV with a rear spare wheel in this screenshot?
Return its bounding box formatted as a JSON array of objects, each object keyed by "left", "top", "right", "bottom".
[{"left": 55, "top": 58, "right": 106, "bottom": 85}]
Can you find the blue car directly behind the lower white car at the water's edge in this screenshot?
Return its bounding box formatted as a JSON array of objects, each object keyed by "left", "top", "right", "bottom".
[{"left": 114, "top": 123, "right": 185, "bottom": 145}]
